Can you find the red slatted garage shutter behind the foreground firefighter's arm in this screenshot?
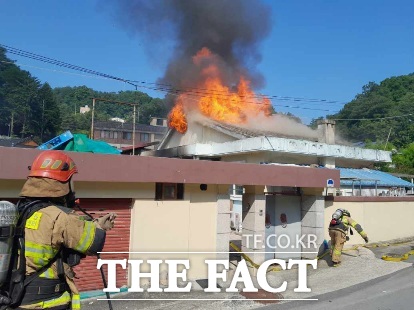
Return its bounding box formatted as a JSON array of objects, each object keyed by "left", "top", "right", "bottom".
[{"left": 75, "top": 198, "right": 132, "bottom": 291}]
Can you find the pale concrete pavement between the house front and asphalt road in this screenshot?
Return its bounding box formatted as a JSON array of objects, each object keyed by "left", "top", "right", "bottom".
[{"left": 82, "top": 242, "right": 414, "bottom": 310}]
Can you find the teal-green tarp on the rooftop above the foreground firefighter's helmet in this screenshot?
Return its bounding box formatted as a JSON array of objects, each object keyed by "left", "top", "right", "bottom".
[{"left": 64, "top": 134, "right": 121, "bottom": 155}]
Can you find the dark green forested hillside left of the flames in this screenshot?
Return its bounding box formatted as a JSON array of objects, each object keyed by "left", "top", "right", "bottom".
[{"left": 0, "top": 48, "right": 168, "bottom": 143}]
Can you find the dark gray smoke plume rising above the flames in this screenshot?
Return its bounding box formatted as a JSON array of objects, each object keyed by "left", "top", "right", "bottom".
[{"left": 105, "top": 0, "right": 271, "bottom": 89}]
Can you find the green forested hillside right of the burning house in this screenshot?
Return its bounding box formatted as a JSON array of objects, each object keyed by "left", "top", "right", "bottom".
[{"left": 329, "top": 74, "right": 414, "bottom": 148}]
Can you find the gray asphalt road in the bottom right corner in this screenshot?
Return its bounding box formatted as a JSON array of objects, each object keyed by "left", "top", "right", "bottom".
[{"left": 260, "top": 267, "right": 414, "bottom": 310}]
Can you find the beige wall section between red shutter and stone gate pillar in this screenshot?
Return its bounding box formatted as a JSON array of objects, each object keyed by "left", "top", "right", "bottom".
[{"left": 130, "top": 185, "right": 222, "bottom": 282}]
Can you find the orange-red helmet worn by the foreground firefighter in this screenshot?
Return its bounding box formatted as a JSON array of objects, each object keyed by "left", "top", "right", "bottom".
[{"left": 29, "top": 150, "right": 78, "bottom": 182}]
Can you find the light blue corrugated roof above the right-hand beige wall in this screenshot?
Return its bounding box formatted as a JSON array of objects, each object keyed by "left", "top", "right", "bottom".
[{"left": 338, "top": 168, "right": 414, "bottom": 187}]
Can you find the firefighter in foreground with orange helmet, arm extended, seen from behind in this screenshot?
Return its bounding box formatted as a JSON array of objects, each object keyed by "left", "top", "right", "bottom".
[{"left": 18, "top": 151, "right": 116, "bottom": 310}]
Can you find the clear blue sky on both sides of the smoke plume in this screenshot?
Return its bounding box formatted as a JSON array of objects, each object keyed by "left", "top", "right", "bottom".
[{"left": 0, "top": 0, "right": 414, "bottom": 123}]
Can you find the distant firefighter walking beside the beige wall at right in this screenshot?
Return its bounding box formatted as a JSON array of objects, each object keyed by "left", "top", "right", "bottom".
[{"left": 329, "top": 209, "right": 368, "bottom": 267}]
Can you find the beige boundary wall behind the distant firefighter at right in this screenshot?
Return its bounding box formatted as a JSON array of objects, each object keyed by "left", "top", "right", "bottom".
[{"left": 325, "top": 201, "right": 414, "bottom": 244}]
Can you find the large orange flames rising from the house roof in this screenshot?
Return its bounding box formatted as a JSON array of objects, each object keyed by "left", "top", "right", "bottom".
[{"left": 168, "top": 48, "right": 271, "bottom": 133}]
